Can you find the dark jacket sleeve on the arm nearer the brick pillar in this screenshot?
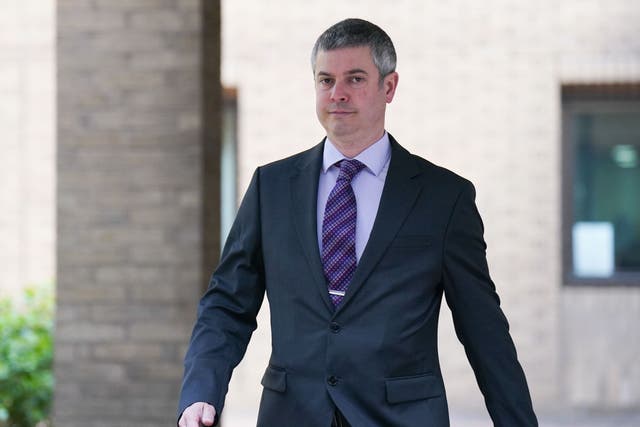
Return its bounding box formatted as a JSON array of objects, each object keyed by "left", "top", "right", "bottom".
[{"left": 178, "top": 169, "right": 265, "bottom": 423}]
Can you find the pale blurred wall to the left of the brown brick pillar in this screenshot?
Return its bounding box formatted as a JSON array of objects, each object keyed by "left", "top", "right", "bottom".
[{"left": 0, "top": 0, "right": 55, "bottom": 296}]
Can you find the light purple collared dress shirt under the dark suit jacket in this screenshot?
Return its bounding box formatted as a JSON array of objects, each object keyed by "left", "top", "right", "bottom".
[{"left": 317, "top": 132, "right": 391, "bottom": 261}]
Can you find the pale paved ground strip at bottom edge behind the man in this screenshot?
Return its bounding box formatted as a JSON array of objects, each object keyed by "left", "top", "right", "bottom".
[{"left": 223, "top": 409, "right": 640, "bottom": 427}]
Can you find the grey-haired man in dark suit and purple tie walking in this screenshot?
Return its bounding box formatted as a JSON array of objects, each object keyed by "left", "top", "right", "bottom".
[{"left": 179, "top": 19, "right": 537, "bottom": 427}]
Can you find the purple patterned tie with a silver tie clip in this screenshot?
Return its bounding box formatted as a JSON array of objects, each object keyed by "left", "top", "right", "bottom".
[{"left": 322, "top": 160, "right": 365, "bottom": 307}]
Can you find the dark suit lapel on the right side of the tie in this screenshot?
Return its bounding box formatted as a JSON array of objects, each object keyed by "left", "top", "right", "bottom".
[{"left": 336, "top": 135, "right": 422, "bottom": 312}]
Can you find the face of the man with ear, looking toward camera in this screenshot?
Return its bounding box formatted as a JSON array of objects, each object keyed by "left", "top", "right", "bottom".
[{"left": 314, "top": 46, "right": 398, "bottom": 144}]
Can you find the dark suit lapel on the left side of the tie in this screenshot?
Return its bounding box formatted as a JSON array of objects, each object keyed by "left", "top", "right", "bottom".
[{"left": 291, "top": 143, "right": 333, "bottom": 311}]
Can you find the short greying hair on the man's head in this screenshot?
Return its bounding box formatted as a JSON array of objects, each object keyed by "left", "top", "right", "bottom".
[{"left": 311, "top": 18, "right": 396, "bottom": 80}]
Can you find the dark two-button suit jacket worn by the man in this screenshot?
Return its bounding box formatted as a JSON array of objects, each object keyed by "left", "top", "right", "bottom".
[{"left": 178, "top": 138, "right": 537, "bottom": 427}]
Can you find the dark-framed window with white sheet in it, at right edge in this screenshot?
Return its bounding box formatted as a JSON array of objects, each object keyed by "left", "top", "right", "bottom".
[{"left": 562, "top": 84, "right": 640, "bottom": 285}]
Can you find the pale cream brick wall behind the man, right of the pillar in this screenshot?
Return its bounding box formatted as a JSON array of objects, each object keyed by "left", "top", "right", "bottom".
[{"left": 222, "top": 0, "right": 640, "bottom": 422}]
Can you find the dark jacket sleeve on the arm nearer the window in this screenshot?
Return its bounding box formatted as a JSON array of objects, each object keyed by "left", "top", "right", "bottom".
[{"left": 443, "top": 181, "right": 538, "bottom": 427}]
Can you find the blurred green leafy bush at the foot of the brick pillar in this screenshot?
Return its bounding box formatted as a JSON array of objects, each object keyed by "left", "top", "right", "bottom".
[{"left": 0, "top": 286, "right": 53, "bottom": 427}]
